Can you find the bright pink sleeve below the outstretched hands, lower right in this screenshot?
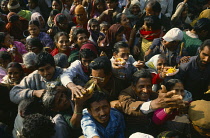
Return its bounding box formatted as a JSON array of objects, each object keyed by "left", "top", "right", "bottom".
[{"left": 152, "top": 108, "right": 178, "bottom": 125}]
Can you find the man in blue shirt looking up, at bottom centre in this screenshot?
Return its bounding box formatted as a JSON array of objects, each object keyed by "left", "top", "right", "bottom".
[{"left": 81, "top": 91, "right": 125, "bottom": 138}]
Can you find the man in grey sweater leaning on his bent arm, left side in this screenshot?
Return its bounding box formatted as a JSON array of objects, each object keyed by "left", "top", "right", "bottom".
[{"left": 10, "top": 52, "right": 63, "bottom": 104}]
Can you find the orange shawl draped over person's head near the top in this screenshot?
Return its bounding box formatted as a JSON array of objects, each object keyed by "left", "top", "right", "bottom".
[{"left": 74, "top": 5, "right": 88, "bottom": 25}]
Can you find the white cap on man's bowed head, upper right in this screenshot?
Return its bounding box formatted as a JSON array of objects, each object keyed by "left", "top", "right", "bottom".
[{"left": 163, "top": 28, "right": 183, "bottom": 42}]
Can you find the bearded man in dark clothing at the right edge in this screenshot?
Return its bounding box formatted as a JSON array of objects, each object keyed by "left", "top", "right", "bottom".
[{"left": 175, "top": 39, "right": 210, "bottom": 100}]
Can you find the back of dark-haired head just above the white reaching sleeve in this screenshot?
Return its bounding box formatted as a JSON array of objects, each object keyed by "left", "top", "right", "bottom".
[{"left": 54, "top": 53, "right": 69, "bottom": 68}]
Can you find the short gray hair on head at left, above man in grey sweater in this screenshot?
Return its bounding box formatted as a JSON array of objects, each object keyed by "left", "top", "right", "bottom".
[{"left": 23, "top": 52, "right": 37, "bottom": 68}]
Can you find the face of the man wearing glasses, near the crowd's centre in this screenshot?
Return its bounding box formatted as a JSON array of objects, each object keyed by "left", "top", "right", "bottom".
[{"left": 92, "top": 69, "right": 111, "bottom": 88}]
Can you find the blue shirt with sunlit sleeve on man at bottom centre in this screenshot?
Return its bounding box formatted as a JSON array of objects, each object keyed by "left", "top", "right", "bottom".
[{"left": 81, "top": 108, "right": 125, "bottom": 138}]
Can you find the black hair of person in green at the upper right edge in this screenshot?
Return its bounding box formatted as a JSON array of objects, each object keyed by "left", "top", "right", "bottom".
[{"left": 193, "top": 18, "right": 210, "bottom": 32}]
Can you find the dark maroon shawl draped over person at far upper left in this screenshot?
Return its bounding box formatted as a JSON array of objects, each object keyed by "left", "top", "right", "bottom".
[{"left": 6, "top": 12, "right": 28, "bottom": 39}]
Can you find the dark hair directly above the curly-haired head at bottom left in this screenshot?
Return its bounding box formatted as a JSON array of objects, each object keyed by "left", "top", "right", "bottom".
[{"left": 18, "top": 98, "right": 43, "bottom": 118}]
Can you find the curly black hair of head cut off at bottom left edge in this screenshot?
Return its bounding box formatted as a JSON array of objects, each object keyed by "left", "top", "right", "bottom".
[{"left": 22, "top": 113, "right": 55, "bottom": 138}]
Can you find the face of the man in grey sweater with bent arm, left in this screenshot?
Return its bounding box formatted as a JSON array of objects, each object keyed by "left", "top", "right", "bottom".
[{"left": 38, "top": 64, "right": 55, "bottom": 81}]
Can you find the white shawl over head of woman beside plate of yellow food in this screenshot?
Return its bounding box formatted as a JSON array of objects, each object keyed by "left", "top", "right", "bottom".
[{"left": 145, "top": 54, "right": 160, "bottom": 74}]
